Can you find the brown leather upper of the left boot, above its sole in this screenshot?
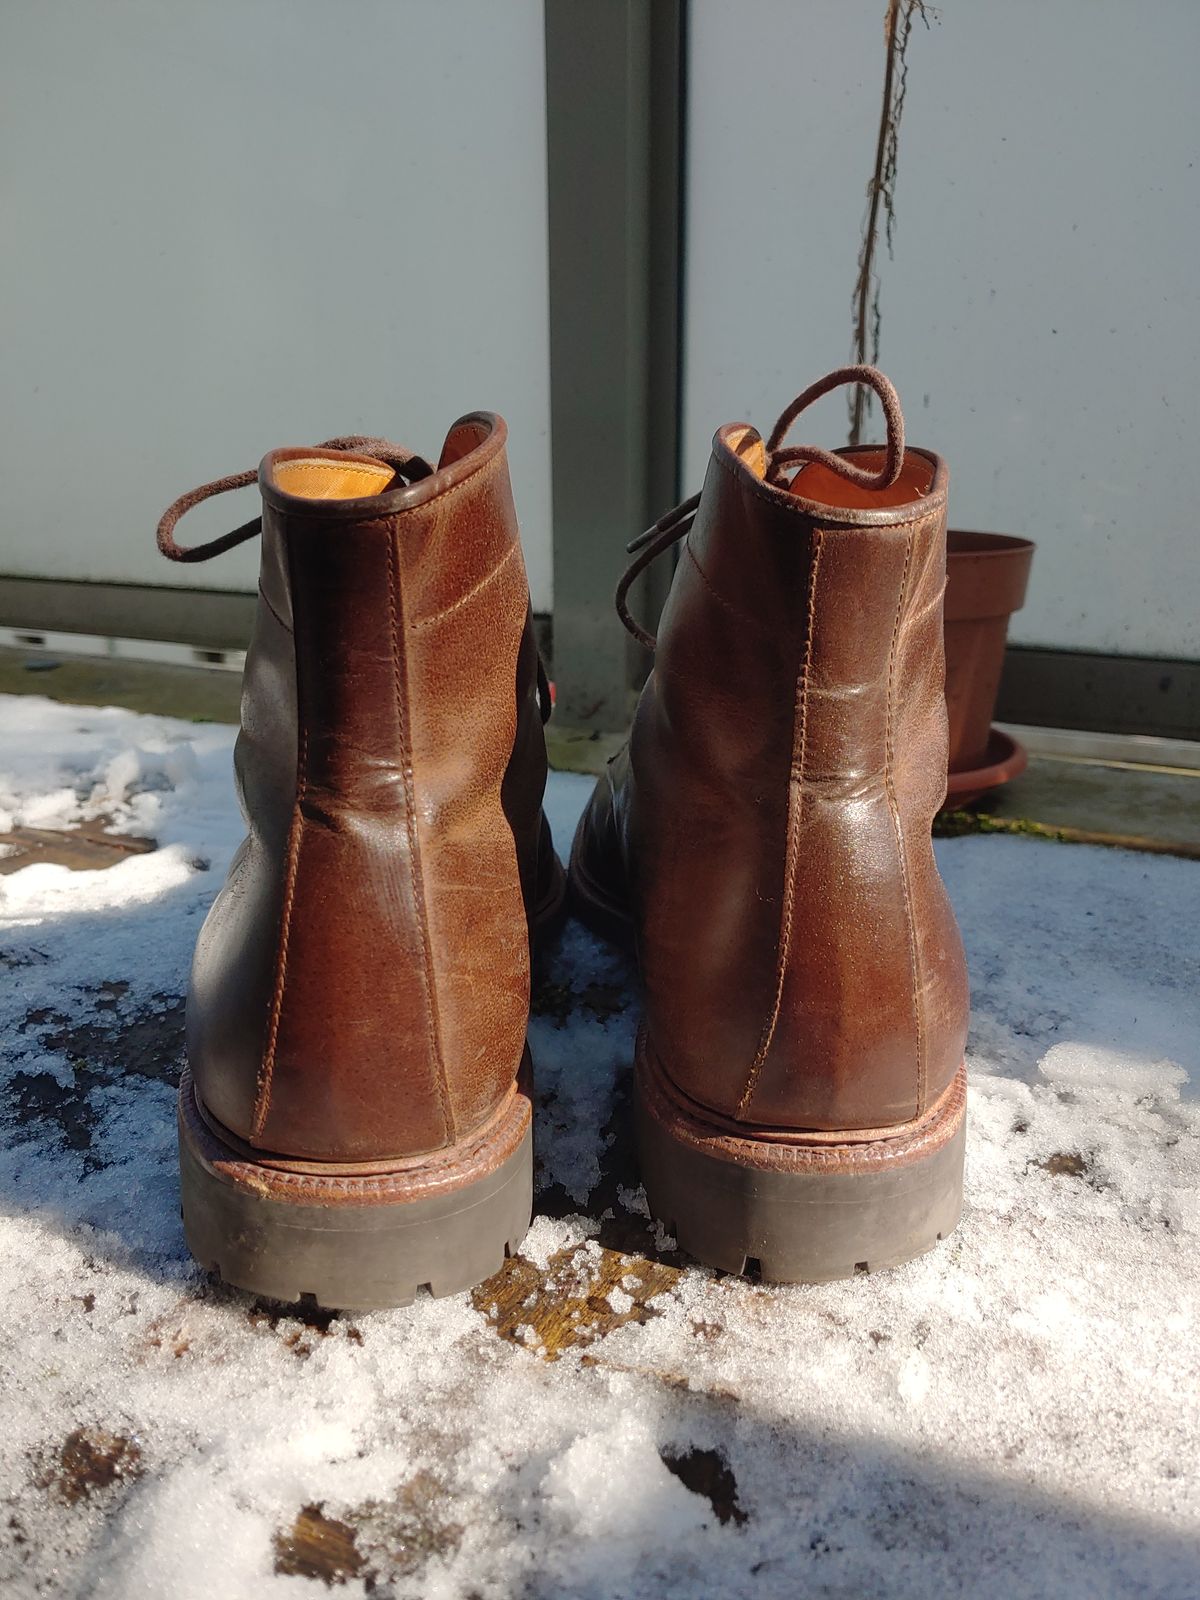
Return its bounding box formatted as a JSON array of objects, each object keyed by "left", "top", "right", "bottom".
[{"left": 187, "top": 414, "right": 555, "bottom": 1162}]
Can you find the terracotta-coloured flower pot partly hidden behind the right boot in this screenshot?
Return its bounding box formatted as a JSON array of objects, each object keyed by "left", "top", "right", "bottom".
[{"left": 946, "top": 528, "right": 1034, "bottom": 805}]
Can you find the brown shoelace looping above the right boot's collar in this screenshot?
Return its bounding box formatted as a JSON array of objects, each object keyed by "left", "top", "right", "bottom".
[{"left": 616, "top": 366, "right": 904, "bottom": 651}]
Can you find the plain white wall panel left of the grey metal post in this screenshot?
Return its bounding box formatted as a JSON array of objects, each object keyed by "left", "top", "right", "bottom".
[{"left": 0, "top": 0, "right": 550, "bottom": 610}]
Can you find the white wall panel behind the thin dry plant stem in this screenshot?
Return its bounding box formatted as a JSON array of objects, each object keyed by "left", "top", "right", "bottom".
[{"left": 685, "top": 0, "right": 1200, "bottom": 658}]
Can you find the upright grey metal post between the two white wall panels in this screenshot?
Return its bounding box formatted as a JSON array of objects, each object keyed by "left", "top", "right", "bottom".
[{"left": 546, "top": 0, "right": 686, "bottom": 731}]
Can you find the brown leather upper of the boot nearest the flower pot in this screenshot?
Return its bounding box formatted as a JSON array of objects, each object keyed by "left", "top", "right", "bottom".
[{"left": 576, "top": 429, "right": 968, "bottom": 1131}]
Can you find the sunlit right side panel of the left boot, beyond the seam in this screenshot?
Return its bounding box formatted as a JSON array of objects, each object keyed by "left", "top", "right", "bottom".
[{"left": 400, "top": 456, "right": 546, "bottom": 1133}]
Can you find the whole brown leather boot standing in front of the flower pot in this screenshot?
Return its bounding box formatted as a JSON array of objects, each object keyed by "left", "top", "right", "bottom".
[{"left": 571, "top": 368, "right": 968, "bottom": 1282}]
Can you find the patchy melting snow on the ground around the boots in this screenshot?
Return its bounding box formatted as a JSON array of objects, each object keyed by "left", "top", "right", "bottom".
[{"left": 0, "top": 698, "right": 1200, "bottom": 1600}]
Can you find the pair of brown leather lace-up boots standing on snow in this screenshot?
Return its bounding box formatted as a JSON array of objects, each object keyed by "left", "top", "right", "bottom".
[{"left": 158, "top": 368, "right": 966, "bottom": 1309}]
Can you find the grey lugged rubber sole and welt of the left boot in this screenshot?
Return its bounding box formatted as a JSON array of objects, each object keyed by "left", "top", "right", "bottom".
[{"left": 179, "top": 1054, "right": 533, "bottom": 1310}]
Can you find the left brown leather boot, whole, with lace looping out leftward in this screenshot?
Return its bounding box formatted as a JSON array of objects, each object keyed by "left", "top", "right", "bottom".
[{"left": 158, "top": 413, "right": 565, "bottom": 1309}]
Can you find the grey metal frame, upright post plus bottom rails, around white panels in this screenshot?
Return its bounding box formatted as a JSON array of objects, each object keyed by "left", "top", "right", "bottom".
[{"left": 0, "top": 0, "right": 1200, "bottom": 739}]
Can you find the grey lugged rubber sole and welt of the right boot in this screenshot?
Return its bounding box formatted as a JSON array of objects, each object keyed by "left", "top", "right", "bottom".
[{"left": 634, "top": 1032, "right": 966, "bottom": 1283}]
